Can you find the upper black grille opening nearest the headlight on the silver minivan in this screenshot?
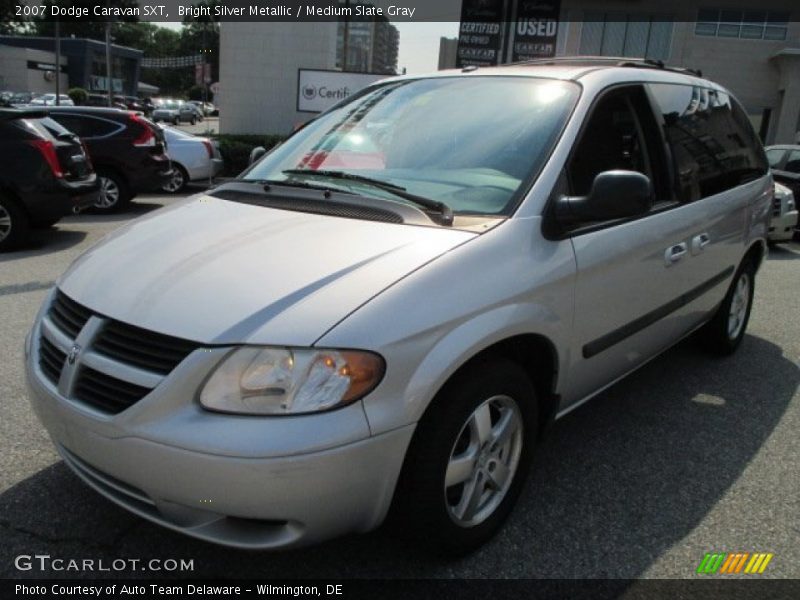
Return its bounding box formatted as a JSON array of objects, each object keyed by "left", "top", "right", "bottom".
[{"left": 93, "top": 321, "right": 197, "bottom": 375}]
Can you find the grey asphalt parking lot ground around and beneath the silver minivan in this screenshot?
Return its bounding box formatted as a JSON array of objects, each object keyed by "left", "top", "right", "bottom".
[{"left": 0, "top": 196, "right": 800, "bottom": 579}]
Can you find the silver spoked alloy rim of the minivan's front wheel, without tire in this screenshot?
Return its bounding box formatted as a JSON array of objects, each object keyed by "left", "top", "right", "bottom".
[{"left": 444, "top": 396, "right": 523, "bottom": 527}]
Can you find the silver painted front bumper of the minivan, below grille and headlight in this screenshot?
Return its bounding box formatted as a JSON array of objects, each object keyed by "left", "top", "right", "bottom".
[{"left": 26, "top": 318, "right": 414, "bottom": 549}]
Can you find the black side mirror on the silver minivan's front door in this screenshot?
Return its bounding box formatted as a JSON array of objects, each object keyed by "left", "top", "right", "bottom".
[{"left": 556, "top": 170, "right": 653, "bottom": 224}]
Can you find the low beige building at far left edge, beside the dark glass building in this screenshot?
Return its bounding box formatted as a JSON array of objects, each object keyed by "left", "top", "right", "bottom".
[{"left": 0, "top": 45, "right": 69, "bottom": 94}]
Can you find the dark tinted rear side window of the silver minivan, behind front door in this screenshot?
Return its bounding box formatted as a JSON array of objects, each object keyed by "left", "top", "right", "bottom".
[{"left": 648, "top": 83, "right": 767, "bottom": 202}]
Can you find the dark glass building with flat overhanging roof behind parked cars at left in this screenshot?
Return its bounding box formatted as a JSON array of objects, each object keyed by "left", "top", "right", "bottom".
[{"left": 0, "top": 36, "right": 144, "bottom": 96}]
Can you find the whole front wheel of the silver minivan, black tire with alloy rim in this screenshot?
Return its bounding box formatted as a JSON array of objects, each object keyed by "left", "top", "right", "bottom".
[{"left": 390, "top": 359, "right": 538, "bottom": 555}]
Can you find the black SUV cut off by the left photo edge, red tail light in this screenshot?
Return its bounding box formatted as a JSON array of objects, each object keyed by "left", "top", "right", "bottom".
[{"left": 0, "top": 108, "right": 100, "bottom": 250}]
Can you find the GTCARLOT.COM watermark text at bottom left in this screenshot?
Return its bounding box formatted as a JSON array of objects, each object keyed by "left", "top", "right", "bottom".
[{"left": 14, "top": 554, "right": 194, "bottom": 573}]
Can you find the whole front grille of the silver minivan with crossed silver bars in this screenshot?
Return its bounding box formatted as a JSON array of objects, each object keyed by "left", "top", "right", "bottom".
[{"left": 39, "top": 290, "right": 198, "bottom": 414}]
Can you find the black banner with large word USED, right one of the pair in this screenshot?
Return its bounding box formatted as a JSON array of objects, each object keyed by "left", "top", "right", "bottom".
[{"left": 511, "top": 0, "right": 561, "bottom": 62}]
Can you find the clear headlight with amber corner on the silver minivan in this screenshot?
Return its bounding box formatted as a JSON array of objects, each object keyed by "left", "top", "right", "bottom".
[{"left": 200, "top": 347, "right": 385, "bottom": 415}]
